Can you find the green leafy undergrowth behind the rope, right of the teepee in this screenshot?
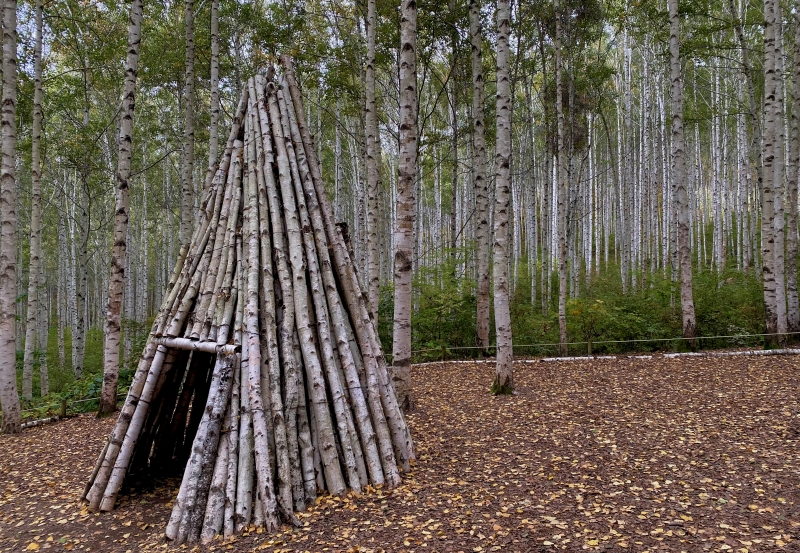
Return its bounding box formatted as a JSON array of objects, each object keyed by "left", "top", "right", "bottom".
[{"left": 378, "top": 257, "right": 776, "bottom": 362}]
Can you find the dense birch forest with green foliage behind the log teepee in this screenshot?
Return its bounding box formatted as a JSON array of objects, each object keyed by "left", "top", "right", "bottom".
[{"left": 0, "top": 0, "right": 800, "bottom": 426}]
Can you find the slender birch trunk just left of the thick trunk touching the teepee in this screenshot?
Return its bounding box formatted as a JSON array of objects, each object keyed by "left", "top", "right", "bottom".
[{"left": 368, "top": 0, "right": 381, "bottom": 321}]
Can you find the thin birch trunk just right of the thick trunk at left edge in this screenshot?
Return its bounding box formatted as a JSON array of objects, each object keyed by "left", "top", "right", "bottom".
[{"left": 22, "top": 0, "right": 42, "bottom": 399}]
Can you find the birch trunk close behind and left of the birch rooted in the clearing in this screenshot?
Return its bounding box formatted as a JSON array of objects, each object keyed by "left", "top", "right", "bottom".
[{"left": 469, "top": 0, "right": 491, "bottom": 353}]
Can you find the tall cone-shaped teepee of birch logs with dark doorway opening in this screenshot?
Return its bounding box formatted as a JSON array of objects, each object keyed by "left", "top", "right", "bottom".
[{"left": 83, "top": 58, "right": 414, "bottom": 543}]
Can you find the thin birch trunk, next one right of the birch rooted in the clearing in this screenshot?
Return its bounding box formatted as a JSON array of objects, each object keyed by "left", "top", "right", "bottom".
[{"left": 554, "top": 0, "right": 568, "bottom": 355}]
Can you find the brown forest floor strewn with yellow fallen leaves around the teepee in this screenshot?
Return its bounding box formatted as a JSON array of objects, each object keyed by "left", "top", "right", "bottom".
[{"left": 0, "top": 356, "right": 800, "bottom": 553}]
